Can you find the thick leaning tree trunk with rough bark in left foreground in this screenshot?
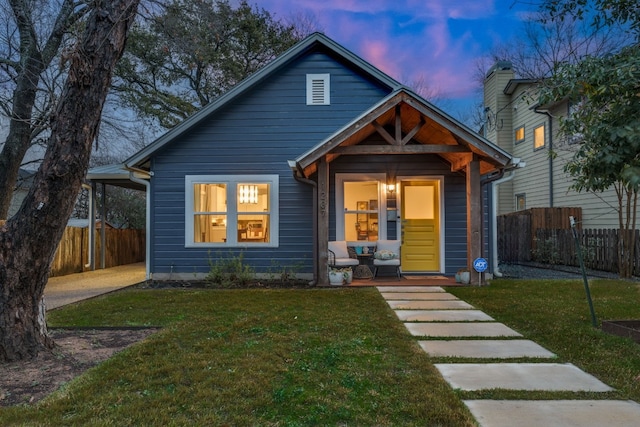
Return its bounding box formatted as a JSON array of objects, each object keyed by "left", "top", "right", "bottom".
[{"left": 0, "top": 0, "right": 139, "bottom": 361}]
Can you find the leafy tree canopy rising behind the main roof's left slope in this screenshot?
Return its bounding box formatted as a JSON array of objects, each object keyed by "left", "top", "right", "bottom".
[{"left": 114, "top": 0, "right": 307, "bottom": 128}]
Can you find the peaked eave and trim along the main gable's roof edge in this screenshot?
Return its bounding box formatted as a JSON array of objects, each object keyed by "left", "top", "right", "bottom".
[{"left": 124, "top": 33, "right": 402, "bottom": 169}]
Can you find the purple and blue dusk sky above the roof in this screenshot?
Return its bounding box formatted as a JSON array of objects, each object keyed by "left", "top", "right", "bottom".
[{"left": 256, "top": 0, "right": 531, "bottom": 118}]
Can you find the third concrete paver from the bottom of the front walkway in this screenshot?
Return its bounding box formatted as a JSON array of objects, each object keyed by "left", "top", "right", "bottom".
[{"left": 418, "top": 340, "right": 555, "bottom": 359}]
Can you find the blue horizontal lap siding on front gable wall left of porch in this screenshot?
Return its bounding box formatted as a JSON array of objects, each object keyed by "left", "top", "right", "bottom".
[{"left": 151, "top": 53, "right": 387, "bottom": 273}]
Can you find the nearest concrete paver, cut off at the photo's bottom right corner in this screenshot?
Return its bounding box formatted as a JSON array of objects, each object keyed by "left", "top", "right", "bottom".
[{"left": 464, "top": 400, "right": 640, "bottom": 427}]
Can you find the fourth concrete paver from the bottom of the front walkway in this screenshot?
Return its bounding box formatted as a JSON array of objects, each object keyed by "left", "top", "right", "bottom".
[{"left": 404, "top": 322, "right": 522, "bottom": 337}]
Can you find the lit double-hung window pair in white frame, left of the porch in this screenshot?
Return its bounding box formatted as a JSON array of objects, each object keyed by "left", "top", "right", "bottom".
[{"left": 185, "top": 175, "right": 279, "bottom": 247}]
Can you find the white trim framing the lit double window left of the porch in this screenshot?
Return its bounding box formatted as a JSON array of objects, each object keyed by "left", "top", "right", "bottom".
[{"left": 184, "top": 175, "right": 280, "bottom": 248}]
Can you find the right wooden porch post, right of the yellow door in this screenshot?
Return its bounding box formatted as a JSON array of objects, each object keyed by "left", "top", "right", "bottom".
[{"left": 467, "top": 155, "right": 482, "bottom": 284}]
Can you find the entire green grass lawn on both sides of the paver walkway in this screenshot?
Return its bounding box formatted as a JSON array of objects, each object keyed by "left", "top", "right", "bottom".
[{"left": 0, "top": 279, "right": 640, "bottom": 427}]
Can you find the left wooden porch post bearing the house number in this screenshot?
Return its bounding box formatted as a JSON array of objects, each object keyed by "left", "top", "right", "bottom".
[{"left": 316, "top": 156, "right": 329, "bottom": 286}]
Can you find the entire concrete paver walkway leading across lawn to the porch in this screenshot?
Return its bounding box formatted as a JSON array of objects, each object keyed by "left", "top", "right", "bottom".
[{"left": 378, "top": 286, "right": 640, "bottom": 427}]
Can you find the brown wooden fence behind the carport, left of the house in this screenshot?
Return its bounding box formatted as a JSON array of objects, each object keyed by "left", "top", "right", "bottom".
[{"left": 51, "top": 227, "right": 146, "bottom": 276}]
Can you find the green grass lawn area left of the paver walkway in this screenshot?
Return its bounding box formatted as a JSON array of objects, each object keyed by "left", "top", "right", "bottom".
[{"left": 0, "top": 288, "right": 474, "bottom": 426}]
